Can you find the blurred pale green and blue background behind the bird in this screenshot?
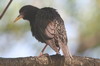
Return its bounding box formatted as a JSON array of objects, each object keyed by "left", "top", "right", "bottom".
[{"left": 0, "top": 0, "right": 100, "bottom": 58}]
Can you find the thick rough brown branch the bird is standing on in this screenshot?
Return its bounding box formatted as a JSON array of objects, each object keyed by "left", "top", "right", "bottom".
[{"left": 0, "top": 55, "right": 100, "bottom": 66}]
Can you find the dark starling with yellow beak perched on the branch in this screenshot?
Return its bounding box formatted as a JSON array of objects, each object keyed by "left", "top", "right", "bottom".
[{"left": 14, "top": 5, "right": 73, "bottom": 58}]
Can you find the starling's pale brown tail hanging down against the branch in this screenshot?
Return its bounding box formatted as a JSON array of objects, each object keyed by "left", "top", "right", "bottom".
[{"left": 59, "top": 42, "right": 73, "bottom": 59}]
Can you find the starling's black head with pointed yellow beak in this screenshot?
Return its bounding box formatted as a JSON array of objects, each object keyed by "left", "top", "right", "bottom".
[{"left": 14, "top": 5, "right": 39, "bottom": 22}]
